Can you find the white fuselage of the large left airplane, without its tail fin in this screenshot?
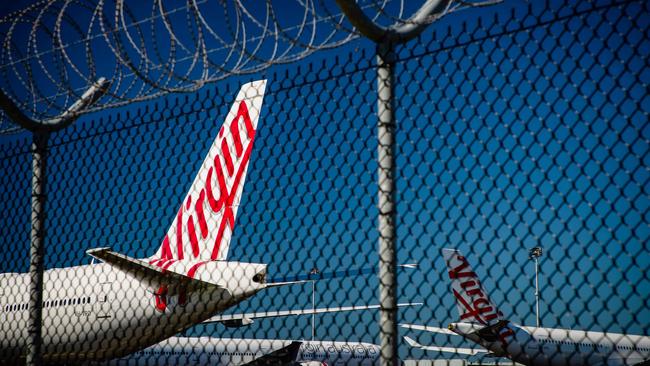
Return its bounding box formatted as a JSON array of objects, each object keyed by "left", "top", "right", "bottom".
[{"left": 0, "top": 262, "right": 266, "bottom": 363}]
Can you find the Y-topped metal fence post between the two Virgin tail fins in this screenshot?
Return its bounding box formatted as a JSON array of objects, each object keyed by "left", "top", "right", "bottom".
[{"left": 336, "top": 0, "right": 500, "bottom": 366}]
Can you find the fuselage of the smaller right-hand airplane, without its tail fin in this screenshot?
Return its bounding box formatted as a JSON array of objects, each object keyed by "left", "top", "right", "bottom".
[{"left": 452, "top": 323, "right": 650, "bottom": 366}]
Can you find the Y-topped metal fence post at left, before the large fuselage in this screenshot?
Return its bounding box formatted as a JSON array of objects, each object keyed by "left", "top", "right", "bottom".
[{"left": 0, "top": 78, "right": 110, "bottom": 365}]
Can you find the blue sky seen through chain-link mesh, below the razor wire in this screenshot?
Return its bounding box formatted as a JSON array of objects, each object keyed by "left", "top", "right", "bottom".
[{"left": 0, "top": 2, "right": 650, "bottom": 357}]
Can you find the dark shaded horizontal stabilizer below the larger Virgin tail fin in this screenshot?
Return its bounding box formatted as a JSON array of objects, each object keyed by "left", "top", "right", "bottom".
[{"left": 86, "top": 248, "right": 216, "bottom": 295}]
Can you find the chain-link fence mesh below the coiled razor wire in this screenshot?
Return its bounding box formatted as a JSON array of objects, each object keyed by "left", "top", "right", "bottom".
[{"left": 0, "top": 1, "right": 650, "bottom": 365}]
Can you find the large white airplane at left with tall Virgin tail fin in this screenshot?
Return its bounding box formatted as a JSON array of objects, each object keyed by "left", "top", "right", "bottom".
[{"left": 0, "top": 80, "right": 288, "bottom": 363}]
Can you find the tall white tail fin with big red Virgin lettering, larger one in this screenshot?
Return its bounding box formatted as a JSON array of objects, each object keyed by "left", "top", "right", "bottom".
[{"left": 149, "top": 80, "right": 266, "bottom": 265}]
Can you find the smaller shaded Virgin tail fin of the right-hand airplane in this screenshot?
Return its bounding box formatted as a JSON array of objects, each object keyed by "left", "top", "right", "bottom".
[{"left": 442, "top": 249, "right": 503, "bottom": 325}]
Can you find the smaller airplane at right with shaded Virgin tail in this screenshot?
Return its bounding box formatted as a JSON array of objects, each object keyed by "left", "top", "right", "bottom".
[{"left": 402, "top": 249, "right": 650, "bottom": 366}]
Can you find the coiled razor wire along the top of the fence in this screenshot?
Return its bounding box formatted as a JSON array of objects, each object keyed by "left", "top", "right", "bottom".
[{"left": 0, "top": 0, "right": 498, "bottom": 134}]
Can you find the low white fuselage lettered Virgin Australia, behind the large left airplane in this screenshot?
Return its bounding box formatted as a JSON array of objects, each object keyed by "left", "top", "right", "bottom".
[{"left": 102, "top": 337, "right": 379, "bottom": 366}]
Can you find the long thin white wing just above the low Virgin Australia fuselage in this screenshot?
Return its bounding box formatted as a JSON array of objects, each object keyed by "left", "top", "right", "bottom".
[{"left": 203, "top": 302, "right": 422, "bottom": 328}]
